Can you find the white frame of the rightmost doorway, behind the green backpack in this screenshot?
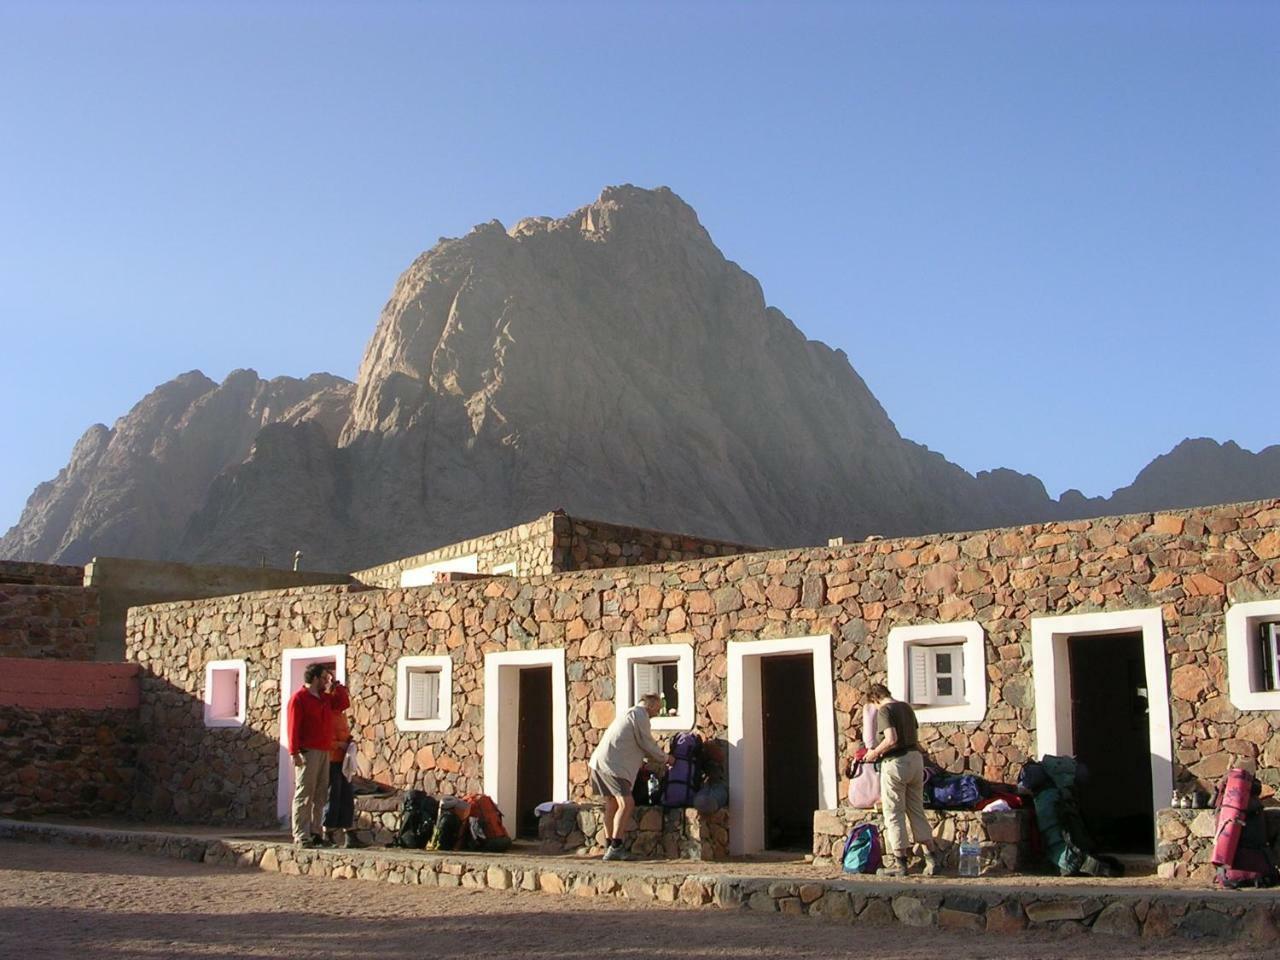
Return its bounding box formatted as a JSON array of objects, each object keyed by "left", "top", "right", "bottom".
[{"left": 1032, "top": 607, "right": 1174, "bottom": 844}]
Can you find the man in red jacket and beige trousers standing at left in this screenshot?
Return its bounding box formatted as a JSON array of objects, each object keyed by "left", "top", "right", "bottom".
[{"left": 289, "top": 663, "right": 351, "bottom": 846}]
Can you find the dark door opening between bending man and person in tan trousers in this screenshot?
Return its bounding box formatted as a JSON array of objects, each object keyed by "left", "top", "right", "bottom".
[{"left": 760, "top": 653, "right": 818, "bottom": 851}]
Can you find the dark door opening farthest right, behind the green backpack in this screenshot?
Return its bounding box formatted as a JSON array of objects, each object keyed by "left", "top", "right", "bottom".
[{"left": 1068, "top": 634, "right": 1156, "bottom": 854}]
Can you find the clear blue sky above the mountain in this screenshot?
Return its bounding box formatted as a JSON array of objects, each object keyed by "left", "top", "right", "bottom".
[{"left": 0, "top": 0, "right": 1280, "bottom": 529}]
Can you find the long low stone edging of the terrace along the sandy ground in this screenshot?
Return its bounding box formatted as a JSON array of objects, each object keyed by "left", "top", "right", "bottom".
[{"left": 0, "top": 820, "right": 1280, "bottom": 945}]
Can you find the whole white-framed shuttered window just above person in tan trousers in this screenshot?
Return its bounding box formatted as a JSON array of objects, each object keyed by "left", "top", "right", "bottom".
[{"left": 886, "top": 620, "right": 987, "bottom": 723}]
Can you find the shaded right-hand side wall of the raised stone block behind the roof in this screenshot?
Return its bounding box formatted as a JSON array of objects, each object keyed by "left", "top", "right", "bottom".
[{"left": 558, "top": 516, "right": 760, "bottom": 572}]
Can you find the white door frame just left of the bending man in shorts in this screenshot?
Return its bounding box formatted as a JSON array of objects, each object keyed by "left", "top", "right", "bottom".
[{"left": 481, "top": 649, "right": 568, "bottom": 836}]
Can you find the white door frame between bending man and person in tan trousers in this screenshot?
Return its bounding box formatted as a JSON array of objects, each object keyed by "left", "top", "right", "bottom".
[{"left": 728, "top": 634, "right": 838, "bottom": 855}]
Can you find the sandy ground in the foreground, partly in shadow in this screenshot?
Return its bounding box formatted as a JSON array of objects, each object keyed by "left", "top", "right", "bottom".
[{"left": 0, "top": 842, "right": 1258, "bottom": 960}]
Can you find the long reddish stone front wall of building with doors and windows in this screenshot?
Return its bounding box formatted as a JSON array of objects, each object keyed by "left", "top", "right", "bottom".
[{"left": 128, "top": 500, "right": 1280, "bottom": 819}]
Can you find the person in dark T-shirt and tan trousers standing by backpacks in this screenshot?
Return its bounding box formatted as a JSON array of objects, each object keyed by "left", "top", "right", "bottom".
[{"left": 864, "top": 684, "right": 941, "bottom": 877}]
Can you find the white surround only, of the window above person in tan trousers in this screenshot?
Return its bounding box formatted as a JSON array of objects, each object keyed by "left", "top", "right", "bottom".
[{"left": 887, "top": 620, "right": 987, "bottom": 723}]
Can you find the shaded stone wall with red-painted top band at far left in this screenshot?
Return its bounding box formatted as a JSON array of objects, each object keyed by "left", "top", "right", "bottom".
[{"left": 0, "top": 659, "right": 138, "bottom": 817}]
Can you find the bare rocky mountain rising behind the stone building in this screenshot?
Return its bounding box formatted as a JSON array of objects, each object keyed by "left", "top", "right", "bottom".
[{"left": 0, "top": 187, "right": 1280, "bottom": 570}]
